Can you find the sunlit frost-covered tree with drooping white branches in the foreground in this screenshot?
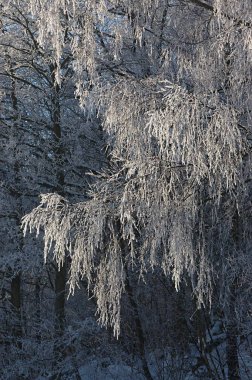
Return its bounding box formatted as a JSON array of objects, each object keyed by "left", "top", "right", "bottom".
[{"left": 10, "top": 0, "right": 251, "bottom": 379}]
